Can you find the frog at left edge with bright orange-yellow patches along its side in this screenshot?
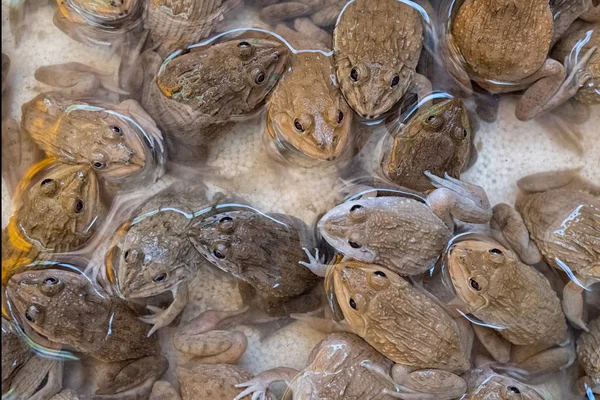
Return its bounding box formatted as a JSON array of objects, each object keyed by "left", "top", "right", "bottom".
[{"left": 2, "top": 159, "right": 106, "bottom": 288}]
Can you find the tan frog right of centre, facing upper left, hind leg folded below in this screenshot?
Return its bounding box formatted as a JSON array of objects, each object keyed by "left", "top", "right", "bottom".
[{"left": 446, "top": 238, "right": 573, "bottom": 377}]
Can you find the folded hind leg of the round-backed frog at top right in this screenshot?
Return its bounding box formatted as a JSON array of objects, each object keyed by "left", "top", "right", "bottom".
[{"left": 515, "top": 58, "right": 566, "bottom": 121}]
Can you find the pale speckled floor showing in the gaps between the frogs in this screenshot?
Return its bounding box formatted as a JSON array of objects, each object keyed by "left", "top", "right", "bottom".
[{"left": 2, "top": 0, "right": 600, "bottom": 396}]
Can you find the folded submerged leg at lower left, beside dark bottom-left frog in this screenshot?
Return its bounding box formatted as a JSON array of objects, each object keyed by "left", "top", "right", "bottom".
[{"left": 173, "top": 307, "right": 248, "bottom": 364}]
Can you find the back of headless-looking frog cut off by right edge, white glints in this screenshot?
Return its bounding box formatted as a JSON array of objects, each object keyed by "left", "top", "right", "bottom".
[{"left": 517, "top": 189, "right": 600, "bottom": 278}]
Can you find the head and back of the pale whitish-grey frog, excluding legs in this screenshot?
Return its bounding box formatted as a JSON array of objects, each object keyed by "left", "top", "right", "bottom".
[{"left": 318, "top": 197, "right": 452, "bottom": 275}]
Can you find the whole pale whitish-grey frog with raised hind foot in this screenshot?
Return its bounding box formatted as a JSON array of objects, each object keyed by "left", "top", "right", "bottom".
[{"left": 317, "top": 171, "right": 492, "bottom": 275}]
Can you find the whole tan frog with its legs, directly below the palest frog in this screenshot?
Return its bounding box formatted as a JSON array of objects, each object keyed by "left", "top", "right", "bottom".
[{"left": 294, "top": 257, "right": 473, "bottom": 400}]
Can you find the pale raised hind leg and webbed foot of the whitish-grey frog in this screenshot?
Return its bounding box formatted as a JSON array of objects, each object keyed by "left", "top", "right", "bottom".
[{"left": 425, "top": 171, "right": 492, "bottom": 230}]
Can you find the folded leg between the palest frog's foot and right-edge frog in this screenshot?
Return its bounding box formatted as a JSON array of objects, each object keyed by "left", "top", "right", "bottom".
[{"left": 490, "top": 203, "right": 542, "bottom": 264}]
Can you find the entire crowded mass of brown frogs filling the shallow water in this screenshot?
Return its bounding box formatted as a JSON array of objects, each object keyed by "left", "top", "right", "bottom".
[{"left": 2, "top": 0, "right": 600, "bottom": 400}]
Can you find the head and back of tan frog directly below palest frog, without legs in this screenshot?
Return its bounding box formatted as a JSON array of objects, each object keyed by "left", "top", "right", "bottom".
[{"left": 326, "top": 261, "right": 471, "bottom": 372}]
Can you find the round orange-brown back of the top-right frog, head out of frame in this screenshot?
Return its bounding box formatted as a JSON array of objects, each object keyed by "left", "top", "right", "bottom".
[{"left": 452, "top": 0, "right": 554, "bottom": 82}]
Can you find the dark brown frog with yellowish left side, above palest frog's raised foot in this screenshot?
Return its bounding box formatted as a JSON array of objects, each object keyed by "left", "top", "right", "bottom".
[{"left": 381, "top": 99, "right": 472, "bottom": 192}]
